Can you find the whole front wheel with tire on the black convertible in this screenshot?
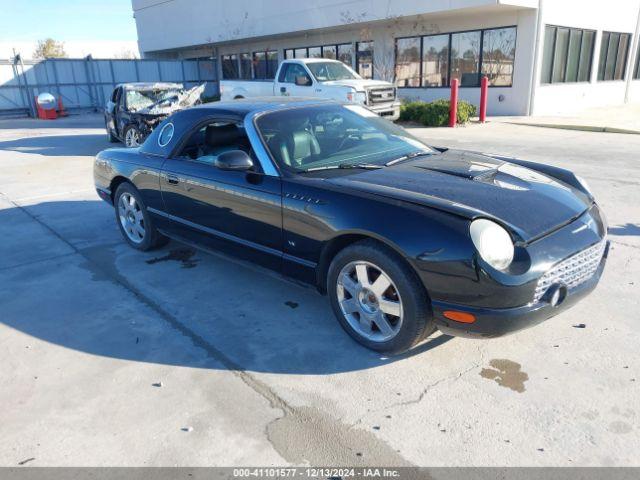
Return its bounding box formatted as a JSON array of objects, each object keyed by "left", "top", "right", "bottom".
[{"left": 327, "top": 240, "right": 436, "bottom": 354}]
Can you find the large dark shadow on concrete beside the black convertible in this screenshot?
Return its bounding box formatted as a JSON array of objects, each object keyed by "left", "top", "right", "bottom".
[{"left": 0, "top": 201, "right": 452, "bottom": 375}]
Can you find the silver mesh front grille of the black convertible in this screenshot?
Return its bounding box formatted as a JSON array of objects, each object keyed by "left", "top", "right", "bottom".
[{"left": 533, "top": 239, "right": 607, "bottom": 303}]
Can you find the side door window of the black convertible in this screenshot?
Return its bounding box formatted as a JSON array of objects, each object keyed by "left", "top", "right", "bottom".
[{"left": 178, "top": 121, "right": 257, "bottom": 171}]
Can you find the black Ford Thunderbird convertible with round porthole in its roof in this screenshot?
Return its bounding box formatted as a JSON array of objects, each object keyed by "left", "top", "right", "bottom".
[{"left": 94, "top": 98, "right": 608, "bottom": 353}]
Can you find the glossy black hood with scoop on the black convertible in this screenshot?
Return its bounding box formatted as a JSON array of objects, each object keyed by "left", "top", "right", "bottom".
[{"left": 326, "top": 150, "right": 591, "bottom": 242}]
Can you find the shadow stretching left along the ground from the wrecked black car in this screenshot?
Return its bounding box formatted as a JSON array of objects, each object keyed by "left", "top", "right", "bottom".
[{"left": 0, "top": 134, "right": 112, "bottom": 157}]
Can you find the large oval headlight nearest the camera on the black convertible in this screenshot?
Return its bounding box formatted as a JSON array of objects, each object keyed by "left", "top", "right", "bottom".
[{"left": 469, "top": 218, "right": 513, "bottom": 270}]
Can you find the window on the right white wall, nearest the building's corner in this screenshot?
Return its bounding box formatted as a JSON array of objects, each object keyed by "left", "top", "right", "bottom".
[{"left": 541, "top": 25, "right": 596, "bottom": 83}]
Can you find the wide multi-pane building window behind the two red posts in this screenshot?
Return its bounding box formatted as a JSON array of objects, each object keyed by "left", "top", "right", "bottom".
[{"left": 395, "top": 27, "right": 516, "bottom": 87}]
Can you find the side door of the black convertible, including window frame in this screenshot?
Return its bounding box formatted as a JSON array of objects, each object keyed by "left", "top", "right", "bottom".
[{"left": 160, "top": 118, "right": 282, "bottom": 270}]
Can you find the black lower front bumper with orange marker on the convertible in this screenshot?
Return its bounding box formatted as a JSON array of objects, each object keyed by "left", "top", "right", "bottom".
[{"left": 432, "top": 242, "right": 609, "bottom": 338}]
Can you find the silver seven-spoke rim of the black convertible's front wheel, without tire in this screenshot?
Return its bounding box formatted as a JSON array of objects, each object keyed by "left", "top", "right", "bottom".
[{"left": 336, "top": 261, "right": 403, "bottom": 342}]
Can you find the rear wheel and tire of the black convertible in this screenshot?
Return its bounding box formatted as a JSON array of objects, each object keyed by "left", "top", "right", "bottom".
[{"left": 114, "top": 182, "right": 169, "bottom": 252}]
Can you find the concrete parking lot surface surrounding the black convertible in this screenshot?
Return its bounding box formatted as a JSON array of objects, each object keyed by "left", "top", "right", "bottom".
[{"left": 0, "top": 115, "right": 640, "bottom": 466}]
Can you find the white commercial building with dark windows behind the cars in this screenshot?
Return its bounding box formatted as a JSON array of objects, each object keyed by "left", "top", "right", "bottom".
[{"left": 132, "top": 0, "right": 640, "bottom": 115}]
